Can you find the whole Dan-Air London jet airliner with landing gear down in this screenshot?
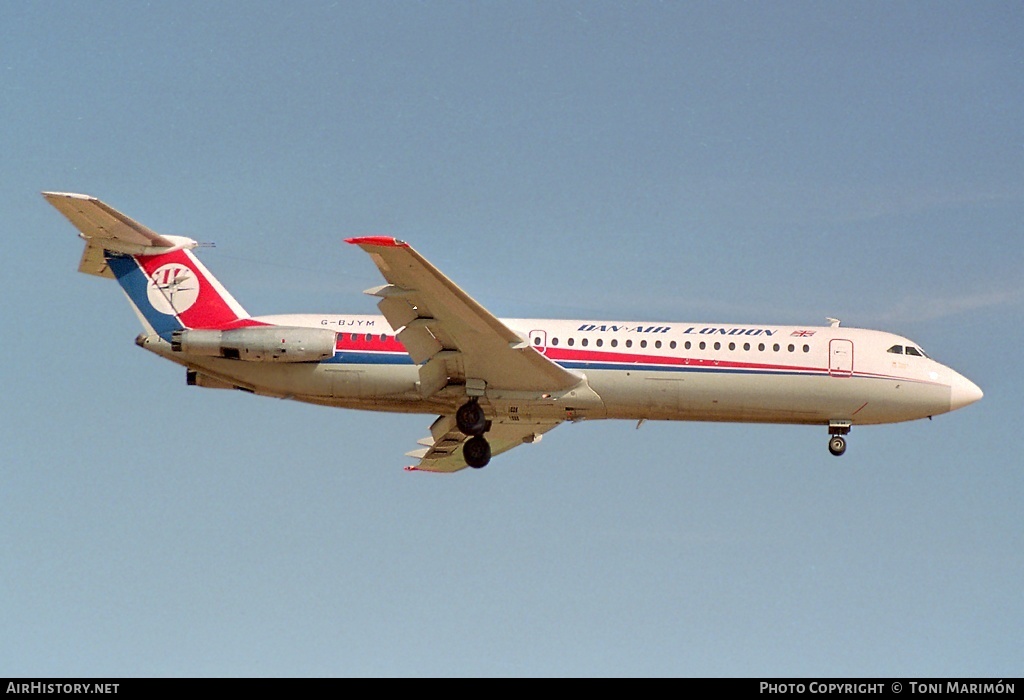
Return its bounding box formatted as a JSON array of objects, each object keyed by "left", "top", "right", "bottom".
[{"left": 43, "top": 192, "right": 982, "bottom": 473}]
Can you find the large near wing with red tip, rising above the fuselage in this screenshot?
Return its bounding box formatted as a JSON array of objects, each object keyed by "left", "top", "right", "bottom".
[{"left": 347, "top": 236, "right": 581, "bottom": 396}]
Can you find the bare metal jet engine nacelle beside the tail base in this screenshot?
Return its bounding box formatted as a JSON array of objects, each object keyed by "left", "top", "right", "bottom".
[{"left": 171, "top": 325, "right": 337, "bottom": 362}]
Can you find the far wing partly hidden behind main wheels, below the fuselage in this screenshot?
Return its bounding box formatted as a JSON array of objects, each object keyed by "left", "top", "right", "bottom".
[{"left": 406, "top": 415, "right": 558, "bottom": 473}]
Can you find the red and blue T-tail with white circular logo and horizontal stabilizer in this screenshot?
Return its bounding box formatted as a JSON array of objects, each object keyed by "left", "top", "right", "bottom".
[{"left": 43, "top": 192, "right": 249, "bottom": 339}]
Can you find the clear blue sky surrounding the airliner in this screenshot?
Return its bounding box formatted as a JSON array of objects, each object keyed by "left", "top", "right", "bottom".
[{"left": 0, "top": 2, "right": 1024, "bottom": 677}]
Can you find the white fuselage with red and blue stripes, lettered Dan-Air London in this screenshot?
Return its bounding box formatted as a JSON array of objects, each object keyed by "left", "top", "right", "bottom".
[{"left": 144, "top": 314, "right": 981, "bottom": 425}]
